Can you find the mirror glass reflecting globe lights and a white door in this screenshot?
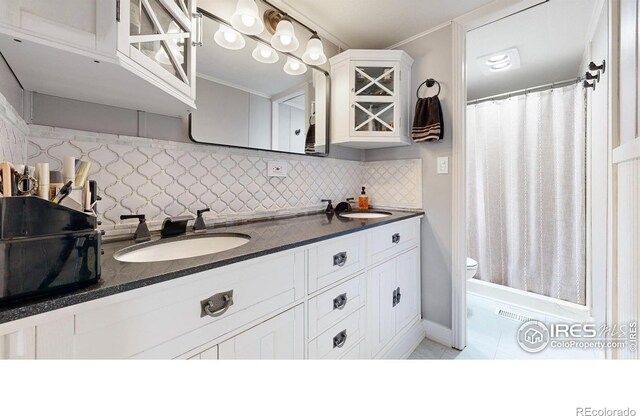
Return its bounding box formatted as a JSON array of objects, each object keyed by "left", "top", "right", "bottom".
[{"left": 189, "top": 9, "right": 330, "bottom": 156}]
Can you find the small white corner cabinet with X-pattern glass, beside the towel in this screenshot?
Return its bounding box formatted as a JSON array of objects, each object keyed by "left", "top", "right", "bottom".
[{"left": 330, "top": 50, "right": 413, "bottom": 149}]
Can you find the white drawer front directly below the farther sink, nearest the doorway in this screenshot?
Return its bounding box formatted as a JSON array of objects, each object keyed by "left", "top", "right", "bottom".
[{"left": 369, "top": 218, "right": 420, "bottom": 264}]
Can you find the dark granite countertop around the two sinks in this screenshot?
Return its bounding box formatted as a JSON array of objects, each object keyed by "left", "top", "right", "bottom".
[{"left": 0, "top": 210, "right": 424, "bottom": 324}]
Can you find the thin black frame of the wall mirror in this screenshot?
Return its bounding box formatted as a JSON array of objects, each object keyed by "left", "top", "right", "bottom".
[{"left": 189, "top": 7, "right": 331, "bottom": 157}]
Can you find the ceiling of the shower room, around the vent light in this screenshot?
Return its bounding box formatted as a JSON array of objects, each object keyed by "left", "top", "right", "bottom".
[{"left": 467, "top": 0, "right": 596, "bottom": 100}]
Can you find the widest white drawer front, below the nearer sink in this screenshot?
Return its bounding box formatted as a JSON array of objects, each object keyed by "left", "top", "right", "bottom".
[{"left": 76, "top": 251, "right": 304, "bottom": 358}]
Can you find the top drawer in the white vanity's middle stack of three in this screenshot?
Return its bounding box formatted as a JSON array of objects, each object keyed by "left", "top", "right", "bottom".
[{"left": 309, "top": 233, "right": 366, "bottom": 293}]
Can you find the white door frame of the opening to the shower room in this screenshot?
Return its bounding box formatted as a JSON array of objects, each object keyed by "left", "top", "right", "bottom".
[{"left": 451, "top": 0, "right": 618, "bottom": 358}]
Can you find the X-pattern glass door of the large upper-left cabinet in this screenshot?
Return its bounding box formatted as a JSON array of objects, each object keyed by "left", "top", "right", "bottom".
[{"left": 129, "top": 0, "right": 192, "bottom": 85}]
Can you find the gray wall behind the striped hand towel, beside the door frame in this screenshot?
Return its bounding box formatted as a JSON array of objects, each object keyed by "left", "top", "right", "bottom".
[{"left": 365, "top": 25, "right": 453, "bottom": 328}]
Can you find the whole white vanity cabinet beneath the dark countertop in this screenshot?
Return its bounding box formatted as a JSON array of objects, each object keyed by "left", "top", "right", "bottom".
[{"left": 0, "top": 217, "right": 425, "bottom": 360}]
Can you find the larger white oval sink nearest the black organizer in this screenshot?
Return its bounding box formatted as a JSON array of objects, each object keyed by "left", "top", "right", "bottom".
[{"left": 113, "top": 233, "right": 251, "bottom": 263}]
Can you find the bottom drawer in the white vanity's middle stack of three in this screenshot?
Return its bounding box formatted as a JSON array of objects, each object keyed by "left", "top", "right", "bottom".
[{"left": 309, "top": 308, "right": 366, "bottom": 360}]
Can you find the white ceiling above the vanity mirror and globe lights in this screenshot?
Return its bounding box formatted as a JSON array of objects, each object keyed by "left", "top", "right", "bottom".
[{"left": 273, "top": 0, "right": 491, "bottom": 49}]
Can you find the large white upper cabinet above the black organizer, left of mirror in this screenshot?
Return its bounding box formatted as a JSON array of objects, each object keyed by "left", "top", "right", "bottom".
[{"left": 0, "top": 0, "right": 201, "bottom": 116}]
